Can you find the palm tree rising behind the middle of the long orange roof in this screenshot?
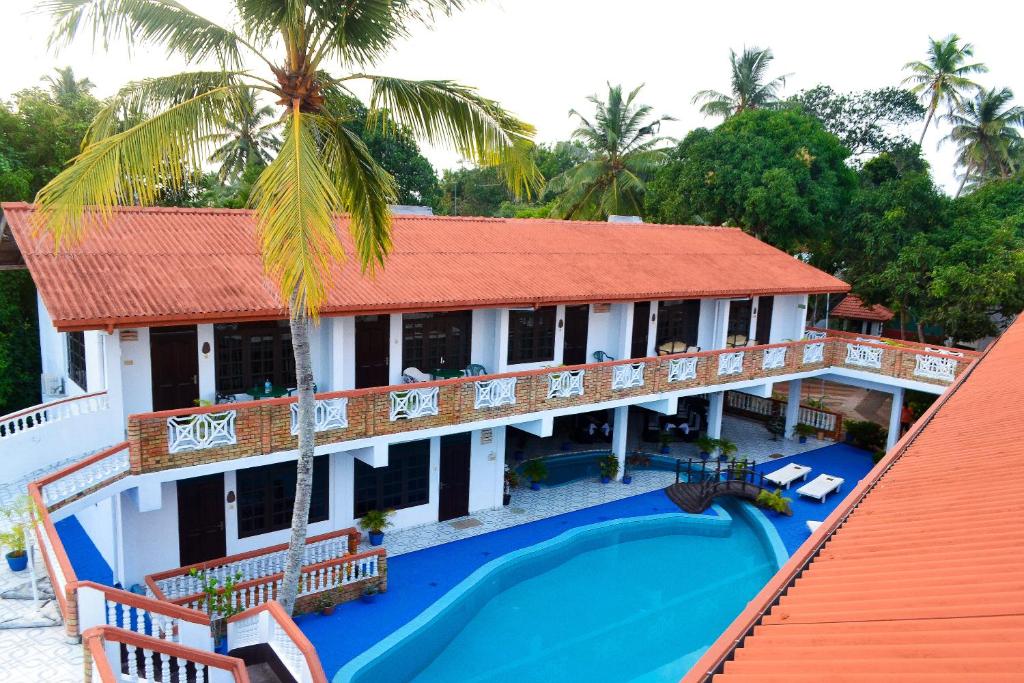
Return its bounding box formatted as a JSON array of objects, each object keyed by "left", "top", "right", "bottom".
[{"left": 545, "top": 83, "right": 673, "bottom": 220}]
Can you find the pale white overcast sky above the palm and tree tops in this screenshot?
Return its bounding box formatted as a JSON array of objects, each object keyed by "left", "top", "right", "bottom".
[{"left": 0, "top": 0, "right": 1024, "bottom": 193}]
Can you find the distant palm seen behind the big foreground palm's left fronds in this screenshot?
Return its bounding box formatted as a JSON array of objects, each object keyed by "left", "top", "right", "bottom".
[{"left": 210, "top": 90, "right": 281, "bottom": 182}]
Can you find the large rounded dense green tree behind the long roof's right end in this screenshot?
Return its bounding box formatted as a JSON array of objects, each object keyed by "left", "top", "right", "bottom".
[{"left": 646, "top": 109, "right": 856, "bottom": 253}]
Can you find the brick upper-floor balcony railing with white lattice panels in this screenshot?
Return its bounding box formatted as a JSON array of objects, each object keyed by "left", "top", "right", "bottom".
[{"left": 128, "top": 330, "right": 977, "bottom": 474}]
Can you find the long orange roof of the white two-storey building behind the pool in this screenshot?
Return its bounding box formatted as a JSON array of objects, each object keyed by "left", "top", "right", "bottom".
[{"left": 0, "top": 204, "right": 849, "bottom": 330}]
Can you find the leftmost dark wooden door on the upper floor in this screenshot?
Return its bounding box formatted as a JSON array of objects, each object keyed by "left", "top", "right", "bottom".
[{"left": 150, "top": 327, "right": 199, "bottom": 411}]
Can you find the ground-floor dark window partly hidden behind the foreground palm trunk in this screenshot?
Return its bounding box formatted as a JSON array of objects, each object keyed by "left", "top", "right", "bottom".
[{"left": 236, "top": 456, "right": 331, "bottom": 539}]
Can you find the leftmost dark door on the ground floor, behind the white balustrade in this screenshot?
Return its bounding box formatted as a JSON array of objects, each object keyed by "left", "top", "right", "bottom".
[{"left": 177, "top": 473, "right": 227, "bottom": 566}]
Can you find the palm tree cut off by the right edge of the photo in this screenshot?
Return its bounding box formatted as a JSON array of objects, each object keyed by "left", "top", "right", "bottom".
[{"left": 943, "top": 88, "right": 1024, "bottom": 197}]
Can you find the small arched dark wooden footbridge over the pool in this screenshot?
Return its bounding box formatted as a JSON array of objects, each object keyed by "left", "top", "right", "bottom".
[{"left": 665, "top": 460, "right": 765, "bottom": 514}]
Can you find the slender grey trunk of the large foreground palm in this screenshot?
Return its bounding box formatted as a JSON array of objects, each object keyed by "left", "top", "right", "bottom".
[{"left": 280, "top": 307, "right": 315, "bottom": 614}]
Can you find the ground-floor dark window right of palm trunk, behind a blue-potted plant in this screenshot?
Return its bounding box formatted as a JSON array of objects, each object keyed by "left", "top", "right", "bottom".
[{"left": 354, "top": 439, "right": 430, "bottom": 517}]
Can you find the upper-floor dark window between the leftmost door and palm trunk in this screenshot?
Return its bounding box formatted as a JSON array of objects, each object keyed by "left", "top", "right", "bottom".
[{"left": 213, "top": 321, "right": 295, "bottom": 393}]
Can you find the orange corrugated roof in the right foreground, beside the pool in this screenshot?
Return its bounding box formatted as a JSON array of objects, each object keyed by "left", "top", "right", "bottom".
[{"left": 684, "top": 318, "right": 1024, "bottom": 683}]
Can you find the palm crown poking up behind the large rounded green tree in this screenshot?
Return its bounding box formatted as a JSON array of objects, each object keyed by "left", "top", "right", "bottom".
[{"left": 692, "top": 47, "right": 788, "bottom": 119}]
